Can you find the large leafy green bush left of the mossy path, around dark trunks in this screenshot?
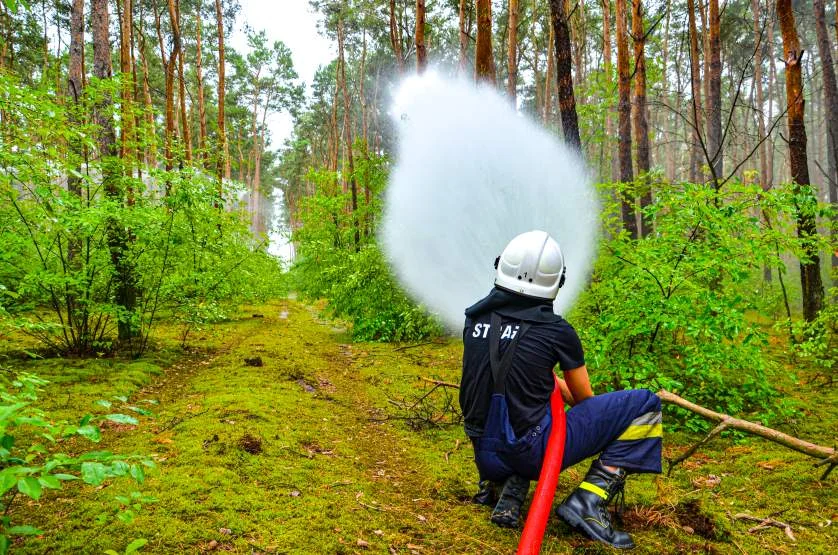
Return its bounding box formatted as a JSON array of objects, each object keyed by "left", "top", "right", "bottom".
[{"left": 0, "top": 74, "right": 281, "bottom": 356}]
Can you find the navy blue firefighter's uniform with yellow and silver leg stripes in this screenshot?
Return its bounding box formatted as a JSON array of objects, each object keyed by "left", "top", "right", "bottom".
[{"left": 460, "top": 288, "right": 662, "bottom": 481}]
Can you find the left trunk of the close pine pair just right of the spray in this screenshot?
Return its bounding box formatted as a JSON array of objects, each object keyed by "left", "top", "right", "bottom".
[{"left": 614, "top": 0, "right": 637, "bottom": 239}]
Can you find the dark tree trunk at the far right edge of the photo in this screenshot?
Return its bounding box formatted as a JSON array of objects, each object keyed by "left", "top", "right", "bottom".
[{"left": 813, "top": 0, "right": 838, "bottom": 268}]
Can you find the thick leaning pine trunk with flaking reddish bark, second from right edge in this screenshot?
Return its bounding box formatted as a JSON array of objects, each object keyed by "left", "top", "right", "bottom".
[{"left": 777, "top": 0, "right": 823, "bottom": 322}]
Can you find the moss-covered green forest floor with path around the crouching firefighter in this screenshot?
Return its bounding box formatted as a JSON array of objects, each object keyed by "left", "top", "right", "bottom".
[{"left": 3, "top": 300, "right": 838, "bottom": 555}]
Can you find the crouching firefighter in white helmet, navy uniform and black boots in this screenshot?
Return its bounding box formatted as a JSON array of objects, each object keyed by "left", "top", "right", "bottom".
[{"left": 460, "top": 231, "right": 662, "bottom": 548}]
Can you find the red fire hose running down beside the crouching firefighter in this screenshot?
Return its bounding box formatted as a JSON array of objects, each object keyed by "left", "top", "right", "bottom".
[{"left": 517, "top": 377, "right": 565, "bottom": 555}]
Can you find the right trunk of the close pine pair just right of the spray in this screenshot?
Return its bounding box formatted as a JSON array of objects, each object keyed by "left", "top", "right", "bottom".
[{"left": 631, "top": 0, "right": 652, "bottom": 237}]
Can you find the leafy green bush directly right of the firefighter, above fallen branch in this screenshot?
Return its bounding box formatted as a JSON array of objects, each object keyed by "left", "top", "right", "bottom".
[{"left": 570, "top": 183, "right": 832, "bottom": 428}]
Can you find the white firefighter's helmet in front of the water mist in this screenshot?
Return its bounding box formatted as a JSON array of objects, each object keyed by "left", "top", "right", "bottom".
[{"left": 495, "top": 230, "right": 565, "bottom": 300}]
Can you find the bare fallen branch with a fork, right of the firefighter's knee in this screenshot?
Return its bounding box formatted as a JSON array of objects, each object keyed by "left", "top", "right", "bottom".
[{"left": 658, "top": 389, "right": 838, "bottom": 480}]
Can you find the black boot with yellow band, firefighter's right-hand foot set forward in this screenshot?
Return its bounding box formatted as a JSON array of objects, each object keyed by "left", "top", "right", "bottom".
[{"left": 556, "top": 459, "right": 634, "bottom": 549}]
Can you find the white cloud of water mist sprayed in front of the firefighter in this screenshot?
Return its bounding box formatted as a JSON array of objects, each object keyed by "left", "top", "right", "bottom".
[{"left": 381, "top": 72, "right": 598, "bottom": 330}]
